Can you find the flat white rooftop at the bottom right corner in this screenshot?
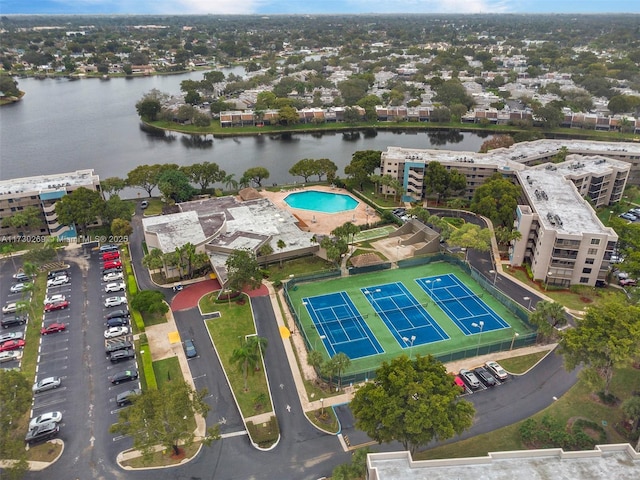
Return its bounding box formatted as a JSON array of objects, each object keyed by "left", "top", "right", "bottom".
[{"left": 367, "top": 444, "right": 640, "bottom": 480}]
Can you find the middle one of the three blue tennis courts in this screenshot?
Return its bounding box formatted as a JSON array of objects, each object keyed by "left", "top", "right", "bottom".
[{"left": 360, "top": 282, "right": 449, "bottom": 348}]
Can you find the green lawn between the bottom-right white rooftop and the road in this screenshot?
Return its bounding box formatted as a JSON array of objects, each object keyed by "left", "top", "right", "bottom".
[{"left": 414, "top": 368, "right": 640, "bottom": 460}]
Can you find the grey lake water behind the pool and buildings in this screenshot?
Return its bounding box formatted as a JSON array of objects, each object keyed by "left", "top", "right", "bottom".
[{"left": 0, "top": 70, "right": 483, "bottom": 194}]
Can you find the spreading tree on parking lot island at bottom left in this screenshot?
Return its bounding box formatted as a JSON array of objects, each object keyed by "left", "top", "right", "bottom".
[{"left": 110, "top": 380, "right": 219, "bottom": 455}]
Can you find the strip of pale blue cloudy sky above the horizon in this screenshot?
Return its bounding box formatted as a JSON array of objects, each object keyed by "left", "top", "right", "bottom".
[{"left": 0, "top": 0, "right": 640, "bottom": 15}]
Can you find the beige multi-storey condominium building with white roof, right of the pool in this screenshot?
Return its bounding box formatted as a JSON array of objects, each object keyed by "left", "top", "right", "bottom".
[{"left": 381, "top": 140, "right": 640, "bottom": 286}]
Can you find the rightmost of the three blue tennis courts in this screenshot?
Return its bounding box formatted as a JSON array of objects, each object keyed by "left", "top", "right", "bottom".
[{"left": 416, "top": 273, "right": 510, "bottom": 335}]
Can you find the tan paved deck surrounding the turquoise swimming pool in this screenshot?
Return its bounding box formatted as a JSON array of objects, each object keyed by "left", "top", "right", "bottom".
[{"left": 260, "top": 185, "right": 380, "bottom": 235}]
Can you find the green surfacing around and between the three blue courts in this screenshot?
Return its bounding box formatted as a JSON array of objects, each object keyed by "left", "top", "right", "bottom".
[{"left": 289, "top": 262, "right": 531, "bottom": 374}]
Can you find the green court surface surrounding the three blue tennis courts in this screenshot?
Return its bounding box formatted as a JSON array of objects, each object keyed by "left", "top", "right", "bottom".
[{"left": 287, "top": 260, "right": 535, "bottom": 381}]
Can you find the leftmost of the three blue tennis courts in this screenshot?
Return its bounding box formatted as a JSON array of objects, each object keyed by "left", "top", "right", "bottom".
[{"left": 302, "top": 292, "right": 384, "bottom": 360}]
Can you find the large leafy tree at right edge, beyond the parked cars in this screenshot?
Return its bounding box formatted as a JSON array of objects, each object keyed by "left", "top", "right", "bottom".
[{"left": 560, "top": 299, "right": 640, "bottom": 395}]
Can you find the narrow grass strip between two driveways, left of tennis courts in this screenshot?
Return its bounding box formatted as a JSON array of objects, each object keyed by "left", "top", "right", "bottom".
[{"left": 200, "top": 292, "right": 273, "bottom": 417}]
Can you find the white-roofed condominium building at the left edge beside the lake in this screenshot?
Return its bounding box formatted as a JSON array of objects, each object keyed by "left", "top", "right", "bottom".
[{"left": 0, "top": 170, "right": 100, "bottom": 242}]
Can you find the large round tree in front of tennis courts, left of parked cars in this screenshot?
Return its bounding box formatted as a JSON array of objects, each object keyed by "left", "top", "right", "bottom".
[{"left": 350, "top": 355, "right": 475, "bottom": 454}]
